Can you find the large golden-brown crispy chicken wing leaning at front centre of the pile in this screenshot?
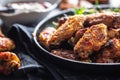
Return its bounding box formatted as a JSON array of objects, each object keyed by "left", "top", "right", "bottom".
[{"left": 74, "top": 23, "right": 107, "bottom": 58}]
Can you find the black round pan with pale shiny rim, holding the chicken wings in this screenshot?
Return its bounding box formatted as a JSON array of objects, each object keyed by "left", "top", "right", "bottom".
[{"left": 33, "top": 10, "right": 120, "bottom": 71}]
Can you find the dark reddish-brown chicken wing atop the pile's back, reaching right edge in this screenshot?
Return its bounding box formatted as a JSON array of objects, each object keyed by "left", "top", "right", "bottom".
[{"left": 84, "top": 12, "right": 120, "bottom": 28}]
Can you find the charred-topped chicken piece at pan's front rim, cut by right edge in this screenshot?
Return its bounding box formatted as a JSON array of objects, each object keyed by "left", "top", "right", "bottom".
[{"left": 96, "top": 38, "right": 120, "bottom": 63}]
